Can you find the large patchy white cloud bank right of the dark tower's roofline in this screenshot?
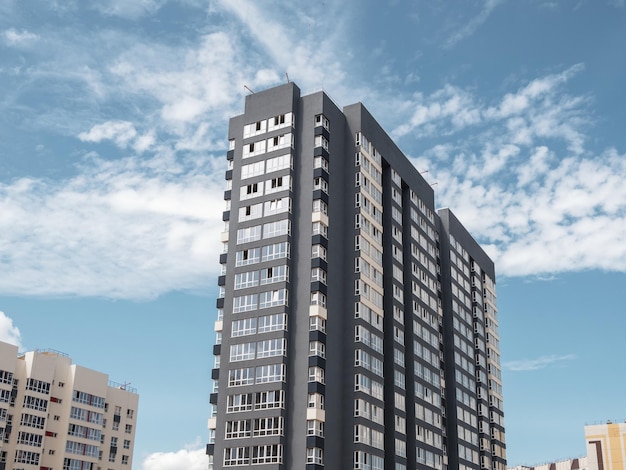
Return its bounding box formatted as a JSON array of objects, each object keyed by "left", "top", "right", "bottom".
[{"left": 402, "top": 65, "right": 626, "bottom": 276}]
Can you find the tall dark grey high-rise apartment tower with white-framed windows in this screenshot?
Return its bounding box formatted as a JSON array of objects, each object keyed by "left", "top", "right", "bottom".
[{"left": 207, "top": 83, "right": 506, "bottom": 470}]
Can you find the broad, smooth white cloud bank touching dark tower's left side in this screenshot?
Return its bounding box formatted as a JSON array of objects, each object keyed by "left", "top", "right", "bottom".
[{"left": 0, "top": 149, "right": 225, "bottom": 299}]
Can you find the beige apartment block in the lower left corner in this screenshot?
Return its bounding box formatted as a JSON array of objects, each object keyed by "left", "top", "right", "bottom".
[{"left": 0, "top": 342, "right": 139, "bottom": 470}]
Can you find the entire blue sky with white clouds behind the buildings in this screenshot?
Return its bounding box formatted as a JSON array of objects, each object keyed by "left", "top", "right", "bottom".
[{"left": 0, "top": 0, "right": 626, "bottom": 470}]
